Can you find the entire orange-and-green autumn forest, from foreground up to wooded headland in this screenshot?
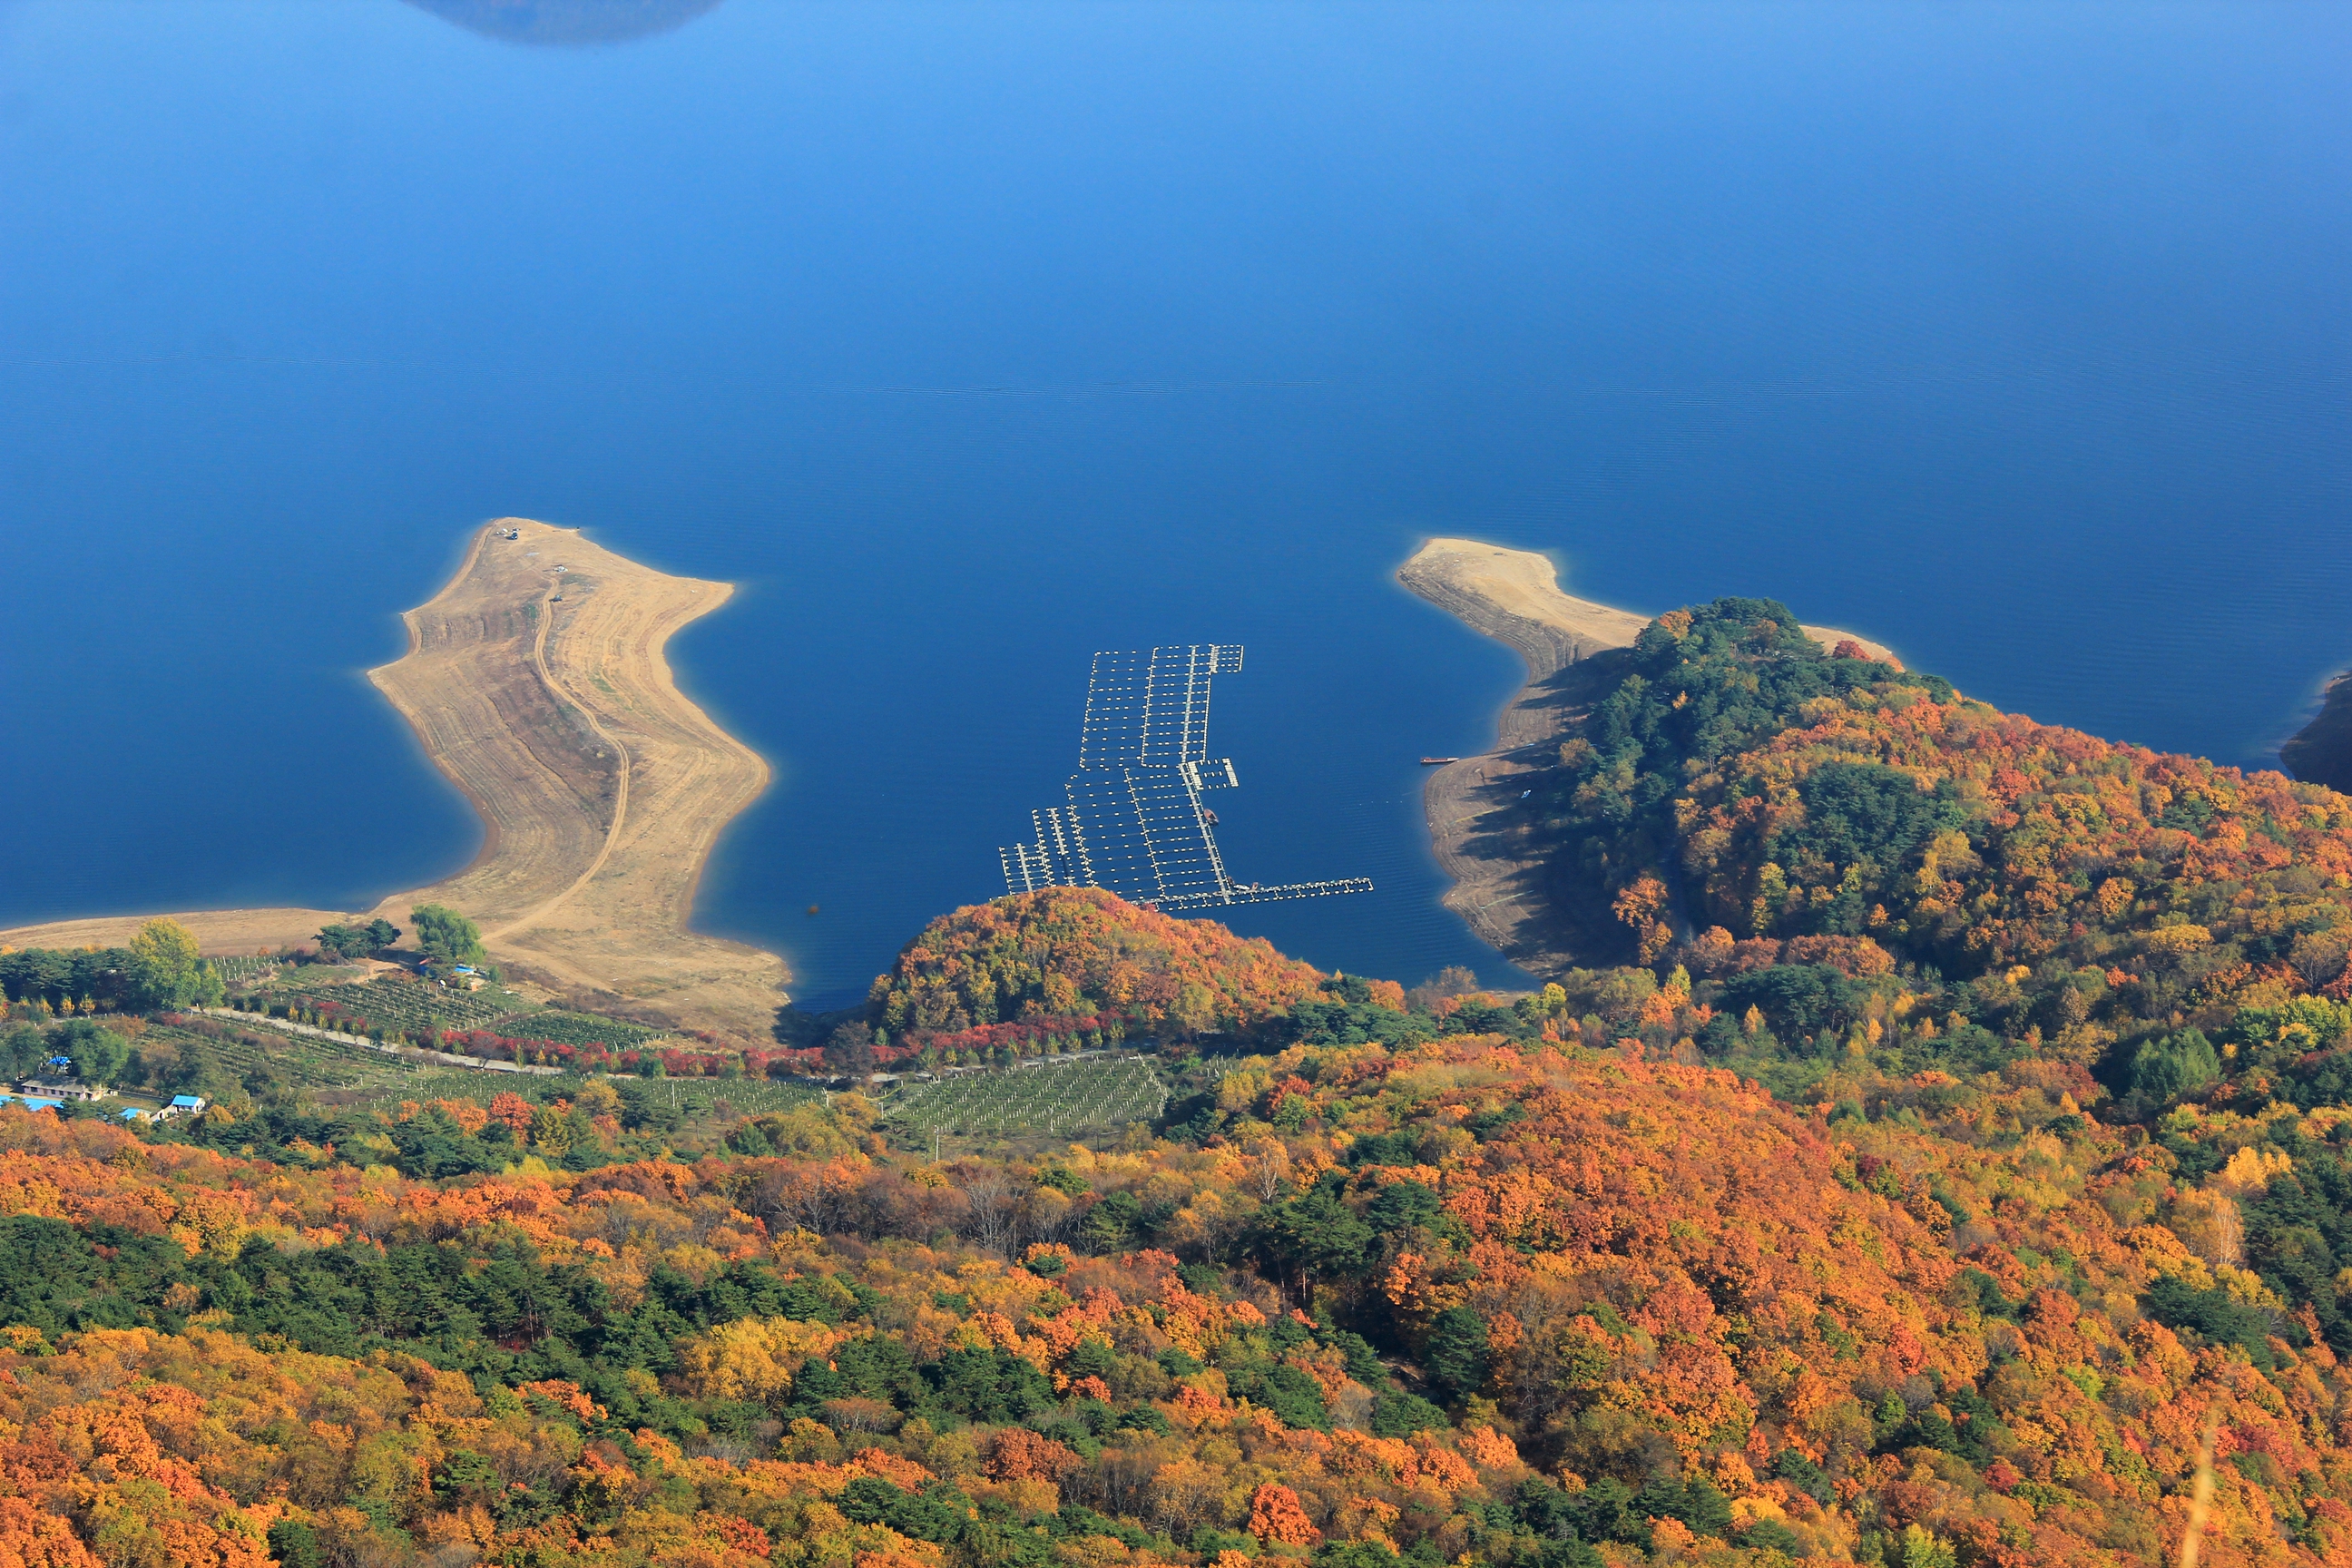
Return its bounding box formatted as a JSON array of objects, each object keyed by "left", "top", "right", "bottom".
[{"left": 23, "top": 600, "right": 2352, "bottom": 1568}]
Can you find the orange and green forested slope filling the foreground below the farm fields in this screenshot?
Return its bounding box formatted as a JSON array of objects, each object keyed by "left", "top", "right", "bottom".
[{"left": 0, "top": 1020, "right": 2352, "bottom": 1568}]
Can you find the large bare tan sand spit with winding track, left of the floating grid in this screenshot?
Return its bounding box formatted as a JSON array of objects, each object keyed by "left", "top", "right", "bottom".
[{"left": 0, "top": 517, "right": 788, "bottom": 1034}]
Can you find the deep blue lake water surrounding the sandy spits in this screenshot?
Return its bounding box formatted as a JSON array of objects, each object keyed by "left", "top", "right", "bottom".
[{"left": 0, "top": 0, "right": 2352, "bottom": 1004}]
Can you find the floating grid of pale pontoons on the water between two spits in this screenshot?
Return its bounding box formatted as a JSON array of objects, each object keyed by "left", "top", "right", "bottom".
[{"left": 997, "top": 642, "right": 1371, "bottom": 915}]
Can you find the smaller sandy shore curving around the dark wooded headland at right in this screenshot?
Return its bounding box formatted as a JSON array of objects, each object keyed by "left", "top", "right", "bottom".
[{"left": 1397, "top": 538, "right": 1894, "bottom": 974}]
